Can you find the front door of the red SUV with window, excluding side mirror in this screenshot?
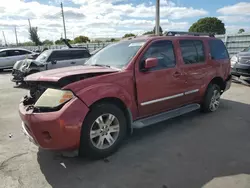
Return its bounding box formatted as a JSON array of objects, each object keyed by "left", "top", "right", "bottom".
[{"left": 135, "top": 39, "right": 185, "bottom": 117}]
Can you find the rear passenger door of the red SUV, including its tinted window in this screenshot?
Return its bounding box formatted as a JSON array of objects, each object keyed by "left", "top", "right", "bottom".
[{"left": 179, "top": 39, "right": 209, "bottom": 103}]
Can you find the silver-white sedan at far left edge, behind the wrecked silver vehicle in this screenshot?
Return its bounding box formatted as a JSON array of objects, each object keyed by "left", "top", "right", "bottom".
[{"left": 0, "top": 48, "right": 38, "bottom": 70}]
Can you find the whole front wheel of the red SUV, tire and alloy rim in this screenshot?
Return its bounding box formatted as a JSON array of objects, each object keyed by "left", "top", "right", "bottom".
[{"left": 79, "top": 103, "right": 127, "bottom": 159}]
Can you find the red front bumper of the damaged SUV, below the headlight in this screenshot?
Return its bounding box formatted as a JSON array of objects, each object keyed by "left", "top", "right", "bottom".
[{"left": 19, "top": 98, "right": 89, "bottom": 151}]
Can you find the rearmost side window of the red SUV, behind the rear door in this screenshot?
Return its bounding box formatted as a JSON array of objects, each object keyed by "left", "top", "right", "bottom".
[{"left": 209, "top": 40, "right": 229, "bottom": 60}]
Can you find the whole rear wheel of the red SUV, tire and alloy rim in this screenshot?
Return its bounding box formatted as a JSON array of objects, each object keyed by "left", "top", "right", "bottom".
[{"left": 201, "top": 84, "right": 221, "bottom": 112}]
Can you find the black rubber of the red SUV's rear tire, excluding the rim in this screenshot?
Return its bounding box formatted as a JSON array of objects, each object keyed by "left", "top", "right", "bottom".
[{"left": 201, "top": 84, "right": 221, "bottom": 112}]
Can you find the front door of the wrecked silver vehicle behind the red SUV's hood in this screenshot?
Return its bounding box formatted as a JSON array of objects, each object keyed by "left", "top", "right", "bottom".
[{"left": 47, "top": 50, "right": 71, "bottom": 70}]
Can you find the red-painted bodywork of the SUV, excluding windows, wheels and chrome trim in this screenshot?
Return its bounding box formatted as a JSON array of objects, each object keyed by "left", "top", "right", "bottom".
[{"left": 19, "top": 37, "right": 230, "bottom": 150}]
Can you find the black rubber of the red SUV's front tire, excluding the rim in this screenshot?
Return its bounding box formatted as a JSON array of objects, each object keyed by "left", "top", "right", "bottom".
[{"left": 79, "top": 103, "right": 127, "bottom": 159}]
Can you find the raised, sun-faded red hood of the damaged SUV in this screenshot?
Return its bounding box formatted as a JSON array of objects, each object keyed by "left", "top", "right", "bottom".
[{"left": 25, "top": 65, "right": 119, "bottom": 82}]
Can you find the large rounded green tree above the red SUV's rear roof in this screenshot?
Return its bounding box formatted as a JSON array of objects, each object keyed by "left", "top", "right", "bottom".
[{"left": 189, "top": 17, "right": 226, "bottom": 34}]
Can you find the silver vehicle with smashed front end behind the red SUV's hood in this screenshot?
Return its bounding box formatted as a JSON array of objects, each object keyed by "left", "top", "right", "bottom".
[{"left": 12, "top": 48, "right": 90, "bottom": 84}]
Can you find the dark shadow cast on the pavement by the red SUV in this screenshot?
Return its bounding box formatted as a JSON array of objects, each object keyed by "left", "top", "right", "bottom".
[{"left": 37, "top": 100, "right": 250, "bottom": 188}]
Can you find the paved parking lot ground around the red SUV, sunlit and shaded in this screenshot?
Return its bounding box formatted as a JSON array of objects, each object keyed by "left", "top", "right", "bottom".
[{"left": 0, "top": 72, "right": 250, "bottom": 188}]
